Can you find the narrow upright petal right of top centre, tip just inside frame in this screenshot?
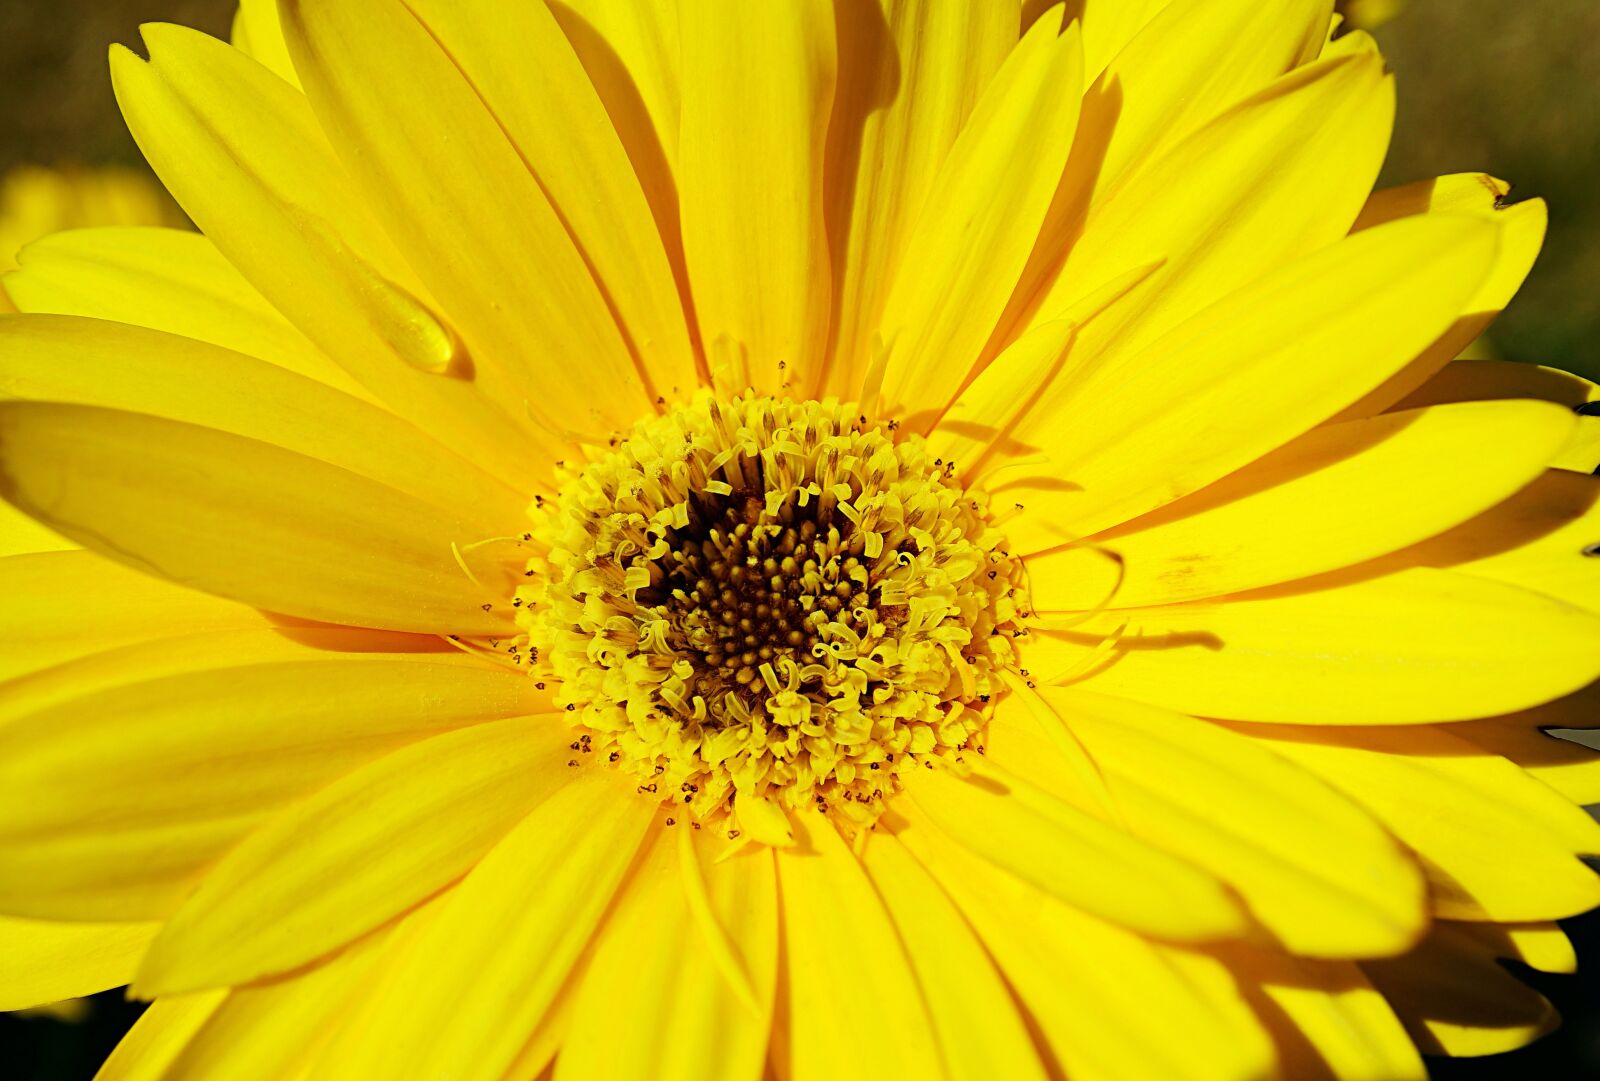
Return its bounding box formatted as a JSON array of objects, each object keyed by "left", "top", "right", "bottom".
[{"left": 878, "top": 18, "right": 1083, "bottom": 416}]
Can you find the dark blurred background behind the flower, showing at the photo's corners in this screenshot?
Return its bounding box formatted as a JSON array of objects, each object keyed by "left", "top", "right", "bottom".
[{"left": 0, "top": 0, "right": 1600, "bottom": 1081}]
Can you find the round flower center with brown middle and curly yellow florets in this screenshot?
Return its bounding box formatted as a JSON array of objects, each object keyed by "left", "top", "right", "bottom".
[{"left": 518, "top": 393, "right": 1024, "bottom": 840}]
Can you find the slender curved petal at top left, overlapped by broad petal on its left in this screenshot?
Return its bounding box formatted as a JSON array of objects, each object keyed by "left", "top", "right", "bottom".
[{"left": 406, "top": 0, "right": 699, "bottom": 406}]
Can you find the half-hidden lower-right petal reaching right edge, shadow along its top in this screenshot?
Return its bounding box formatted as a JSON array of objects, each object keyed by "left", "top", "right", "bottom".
[{"left": 1235, "top": 726, "right": 1600, "bottom": 921}]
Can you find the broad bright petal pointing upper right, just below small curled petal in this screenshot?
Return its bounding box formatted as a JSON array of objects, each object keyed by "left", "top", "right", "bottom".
[{"left": 992, "top": 216, "right": 1496, "bottom": 552}]
